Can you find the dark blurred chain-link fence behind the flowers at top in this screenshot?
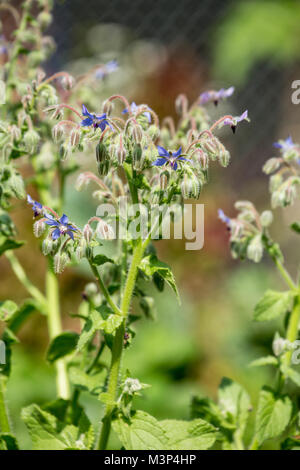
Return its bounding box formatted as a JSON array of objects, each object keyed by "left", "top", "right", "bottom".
[{"left": 50, "top": 0, "right": 297, "bottom": 184}]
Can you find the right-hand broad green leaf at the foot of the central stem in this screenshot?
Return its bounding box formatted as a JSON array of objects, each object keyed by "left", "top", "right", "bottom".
[{"left": 159, "top": 419, "right": 217, "bottom": 450}]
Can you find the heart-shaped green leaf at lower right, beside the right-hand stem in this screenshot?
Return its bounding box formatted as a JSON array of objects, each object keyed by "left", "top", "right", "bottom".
[{"left": 255, "top": 388, "right": 292, "bottom": 445}]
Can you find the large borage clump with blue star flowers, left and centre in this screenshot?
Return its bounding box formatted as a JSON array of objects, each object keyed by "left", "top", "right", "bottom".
[{"left": 0, "top": 0, "right": 255, "bottom": 449}]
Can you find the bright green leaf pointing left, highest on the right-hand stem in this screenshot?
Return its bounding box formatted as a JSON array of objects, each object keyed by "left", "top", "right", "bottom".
[{"left": 254, "top": 290, "right": 295, "bottom": 321}]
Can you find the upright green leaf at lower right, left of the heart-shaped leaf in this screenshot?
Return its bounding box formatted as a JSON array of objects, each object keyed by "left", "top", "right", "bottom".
[{"left": 218, "top": 377, "right": 251, "bottom": 432}]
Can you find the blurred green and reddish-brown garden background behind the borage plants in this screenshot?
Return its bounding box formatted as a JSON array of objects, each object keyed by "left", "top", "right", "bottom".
[{"left": 0, "top": 0, "right": 300, "bottom": 447}]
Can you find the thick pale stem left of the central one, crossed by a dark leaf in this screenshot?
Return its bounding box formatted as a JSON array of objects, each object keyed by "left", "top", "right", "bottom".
[{"left": 46, "top": 262, "right": 70, "bottom": 400}]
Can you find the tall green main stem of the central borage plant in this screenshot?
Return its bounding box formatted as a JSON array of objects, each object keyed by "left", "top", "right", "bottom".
[{"left": 98, "top": 240, "right": 148, "bottom": 450}]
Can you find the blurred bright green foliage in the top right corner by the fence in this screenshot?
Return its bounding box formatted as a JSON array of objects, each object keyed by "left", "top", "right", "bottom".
[{"left": 213, "top": 0, "right": 300, "bottom": 84}]
